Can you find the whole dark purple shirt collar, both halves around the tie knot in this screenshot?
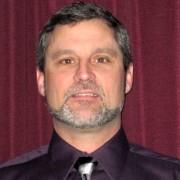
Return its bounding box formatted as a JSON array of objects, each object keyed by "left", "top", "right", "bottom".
[{"left": 48, "top": 128, "right": 129, "bottom": 179}]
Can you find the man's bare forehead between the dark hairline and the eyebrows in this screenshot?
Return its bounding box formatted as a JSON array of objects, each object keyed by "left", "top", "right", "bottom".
[{"left": 46, "top": 19, "right": 119, "bottom": 55}]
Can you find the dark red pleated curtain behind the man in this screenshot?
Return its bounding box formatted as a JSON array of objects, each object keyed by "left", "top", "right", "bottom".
[{"left": 0, "top": 0, "right": 180, "bottom": 163}]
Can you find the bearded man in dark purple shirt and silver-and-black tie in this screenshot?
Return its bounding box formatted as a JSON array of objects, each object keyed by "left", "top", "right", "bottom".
[{"left": 0, "top": 2, "right": 180, "bottom": 180}]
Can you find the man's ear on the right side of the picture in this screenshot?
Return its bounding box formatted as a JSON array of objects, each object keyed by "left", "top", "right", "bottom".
[{"left": 125, "top": 63, "right": 133, "bottom": 94}]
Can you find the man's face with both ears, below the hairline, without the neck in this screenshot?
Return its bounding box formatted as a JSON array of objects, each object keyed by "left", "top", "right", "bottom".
[{"left": 37, "top": 19, "right": 132, "bottom": 127}]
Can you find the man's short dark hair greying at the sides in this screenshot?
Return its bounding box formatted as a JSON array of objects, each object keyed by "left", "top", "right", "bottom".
[{"left": 37, "top": 2, "right": 131, "bottom": 71}]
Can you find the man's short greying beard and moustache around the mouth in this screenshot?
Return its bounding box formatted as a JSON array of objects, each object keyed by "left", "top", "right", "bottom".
[{"left": 45, "top": 82, "right": 124, "bottom": 129}]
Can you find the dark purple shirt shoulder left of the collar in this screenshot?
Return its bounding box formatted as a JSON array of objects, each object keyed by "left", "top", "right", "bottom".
[{"left": 0, "top": 146, "right": 49, "bottom": 180}]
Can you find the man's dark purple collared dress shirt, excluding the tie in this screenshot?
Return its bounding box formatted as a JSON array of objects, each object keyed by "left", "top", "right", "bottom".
[{"left": 0, "top": 129, "right": 180, "bottom": 180}]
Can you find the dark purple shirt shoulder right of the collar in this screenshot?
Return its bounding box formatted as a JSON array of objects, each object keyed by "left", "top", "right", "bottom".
[{"left": 128, "top": 143, "right": 180, "bottom": 179}]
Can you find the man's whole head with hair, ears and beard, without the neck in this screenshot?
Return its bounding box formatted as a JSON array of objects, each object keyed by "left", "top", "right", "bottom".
[{"left": 37, "top": 3, "right": 133, "bottom": 128}]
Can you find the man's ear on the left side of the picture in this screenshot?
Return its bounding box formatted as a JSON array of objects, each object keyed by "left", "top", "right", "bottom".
[{"left": 36, "top": 68, "right": 45, "bottom": 96}]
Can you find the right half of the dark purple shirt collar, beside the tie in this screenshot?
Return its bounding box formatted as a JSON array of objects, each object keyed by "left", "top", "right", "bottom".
[{"left": 91, "top": 128, "right": 129, "bottom": 179}]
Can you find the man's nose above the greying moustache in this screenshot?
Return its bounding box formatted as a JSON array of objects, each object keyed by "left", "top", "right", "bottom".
[{"left": 74, "top": 63, "right": 95, "bottom": 82}]
